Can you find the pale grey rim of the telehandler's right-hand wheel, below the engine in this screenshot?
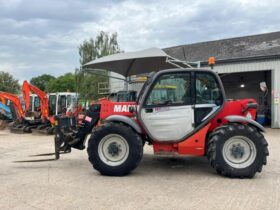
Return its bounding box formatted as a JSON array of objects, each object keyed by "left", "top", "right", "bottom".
[{"left": 223, "top": 136, "right": 257, "bottom": 169}]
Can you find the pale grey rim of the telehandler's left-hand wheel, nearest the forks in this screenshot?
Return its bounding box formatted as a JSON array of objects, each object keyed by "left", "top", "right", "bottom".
[{"left": 98, "top": 134, "right": 129, "bottom": 166}]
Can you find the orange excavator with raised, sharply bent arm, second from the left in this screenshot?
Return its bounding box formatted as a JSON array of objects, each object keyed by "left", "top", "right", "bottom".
[{"left": 22, "top": 80, "right": 54, "bottom": 134}]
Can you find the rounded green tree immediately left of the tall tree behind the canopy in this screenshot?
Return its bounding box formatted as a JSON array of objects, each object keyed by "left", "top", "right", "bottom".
[{"left": 47, "top": 73, "right": 76, "bottom": 92}]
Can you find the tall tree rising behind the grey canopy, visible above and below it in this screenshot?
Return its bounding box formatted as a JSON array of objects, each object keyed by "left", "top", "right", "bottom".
[{"left": 76, "top": 31, "right": 121, "bottom": 100}]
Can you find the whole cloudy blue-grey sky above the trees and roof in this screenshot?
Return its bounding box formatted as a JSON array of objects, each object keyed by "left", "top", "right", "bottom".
[{"left": 0, "top": 0, "right": 280, "bottom": 81}]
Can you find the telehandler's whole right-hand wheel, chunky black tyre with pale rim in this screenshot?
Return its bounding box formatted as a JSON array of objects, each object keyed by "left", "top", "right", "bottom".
[{"left": 207, "top": 124, "right": 269, "bottom": 178}]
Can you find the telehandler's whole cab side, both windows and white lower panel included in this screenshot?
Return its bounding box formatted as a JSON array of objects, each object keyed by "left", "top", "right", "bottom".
[{"left": 138, "top": 69, "right": 225, "bottom": 142}]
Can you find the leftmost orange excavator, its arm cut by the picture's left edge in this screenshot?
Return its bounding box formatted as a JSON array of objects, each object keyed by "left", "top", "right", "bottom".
[{"left": 0, "top": 92, "right": 41, "bottom": 133}]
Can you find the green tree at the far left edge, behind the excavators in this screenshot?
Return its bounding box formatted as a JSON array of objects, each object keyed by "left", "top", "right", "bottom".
[{"left": 0, "top": 71, "right": 20, "bottom": 93}]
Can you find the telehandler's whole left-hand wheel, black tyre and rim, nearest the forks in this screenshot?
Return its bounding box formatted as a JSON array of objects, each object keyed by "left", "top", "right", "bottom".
[{"left": 87, "top": 123, "right": 143, "bottom": 176}]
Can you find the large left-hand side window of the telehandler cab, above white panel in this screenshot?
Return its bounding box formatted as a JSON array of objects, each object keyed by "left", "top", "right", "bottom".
[{"left": 145, "top": 73, "right": 191, "bottom": 106}]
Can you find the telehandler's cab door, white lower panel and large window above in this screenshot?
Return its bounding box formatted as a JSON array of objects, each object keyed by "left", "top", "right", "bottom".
[{"left": 139, "top": 71, "right": 195, "bottom": 141}]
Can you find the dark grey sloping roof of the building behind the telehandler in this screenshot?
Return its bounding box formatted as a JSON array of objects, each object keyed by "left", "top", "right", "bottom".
[{"left": 163, "top": 31, "right": 280, "bottom": 62}]
